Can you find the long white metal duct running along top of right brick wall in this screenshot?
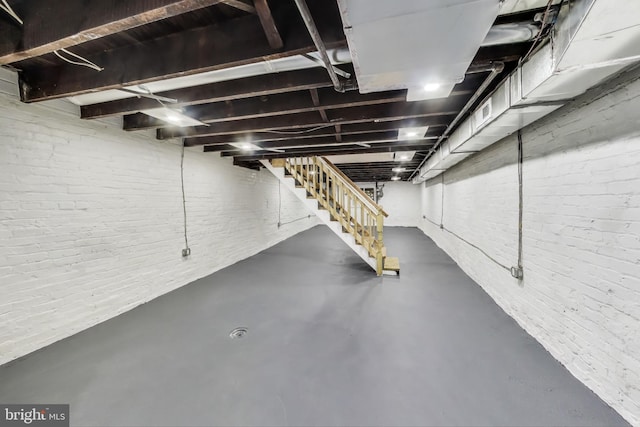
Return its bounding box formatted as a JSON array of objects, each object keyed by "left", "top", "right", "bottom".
[{"left": 413, "top": 0, "right": 640, "bottom": 184}]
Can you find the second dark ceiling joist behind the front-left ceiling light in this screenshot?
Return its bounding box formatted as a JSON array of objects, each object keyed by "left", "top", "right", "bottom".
[{"left": 183, "top": 118, "right": 446, "bottom": 147}]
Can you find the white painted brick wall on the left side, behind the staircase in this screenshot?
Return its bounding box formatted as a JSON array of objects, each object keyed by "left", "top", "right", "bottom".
[{"left": 0, "top": 70, "right": 317, "bottom": 364}]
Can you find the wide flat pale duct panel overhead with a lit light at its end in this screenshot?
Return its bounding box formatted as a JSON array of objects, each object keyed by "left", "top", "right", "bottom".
[{"left": 338, "top": 0, "right": 500, "bottom": 101}]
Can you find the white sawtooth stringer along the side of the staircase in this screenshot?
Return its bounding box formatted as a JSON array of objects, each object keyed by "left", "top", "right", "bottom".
[{"left": 260, "top": 160, "right": 376, "bottom": 271}]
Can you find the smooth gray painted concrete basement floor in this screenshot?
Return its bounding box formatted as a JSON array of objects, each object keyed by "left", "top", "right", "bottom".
[{"left": 0, "top": 226, "right": 628, "bottom": 426}]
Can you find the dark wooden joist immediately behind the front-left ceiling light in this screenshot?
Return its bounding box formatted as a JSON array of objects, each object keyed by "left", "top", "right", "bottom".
[{"left": 157, "top": 102, "right": 460, "bottom": 139}]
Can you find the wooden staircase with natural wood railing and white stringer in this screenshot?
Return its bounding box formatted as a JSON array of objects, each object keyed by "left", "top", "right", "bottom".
[{"left": 262, "top": 157, "right": 400, "bottom": 276}]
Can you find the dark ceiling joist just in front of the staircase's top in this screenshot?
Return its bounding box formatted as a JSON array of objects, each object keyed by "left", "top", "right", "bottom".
[{"left": 222, "top": 142, "right": 433, "bottom": 162}]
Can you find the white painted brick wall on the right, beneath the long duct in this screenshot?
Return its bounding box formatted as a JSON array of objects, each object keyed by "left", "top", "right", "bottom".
[{"left": 420, "top": 65, "right": 640, "bottom": 425}]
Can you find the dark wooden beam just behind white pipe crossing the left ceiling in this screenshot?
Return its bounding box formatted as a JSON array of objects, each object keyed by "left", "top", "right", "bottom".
[{"left": 80, "top": 68, "right": 333, "bottom": 119}]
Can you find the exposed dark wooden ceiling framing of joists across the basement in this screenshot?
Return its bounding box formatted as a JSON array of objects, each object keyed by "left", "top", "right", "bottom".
[{"left": 0, "top": 0, "right": 539, "bottom": 181}]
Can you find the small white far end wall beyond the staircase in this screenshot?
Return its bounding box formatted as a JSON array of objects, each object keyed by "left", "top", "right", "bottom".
[{"left": 356, "top": 181, "right": 421, "bottom": 227}]
